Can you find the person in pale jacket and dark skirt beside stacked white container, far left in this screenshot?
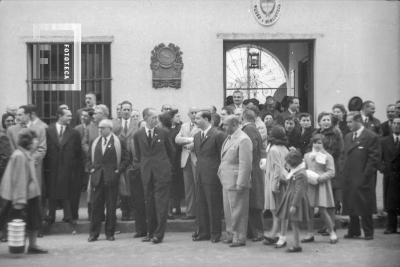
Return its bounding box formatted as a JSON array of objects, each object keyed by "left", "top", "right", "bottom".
[{"left": 0, "top": 129, "right": 47, "bottom": 254}]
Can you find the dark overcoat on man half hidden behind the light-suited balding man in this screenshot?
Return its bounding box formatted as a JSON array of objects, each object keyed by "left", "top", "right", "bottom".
[{"left": 242, "top": 123, "right": 265, "bottom": 209}]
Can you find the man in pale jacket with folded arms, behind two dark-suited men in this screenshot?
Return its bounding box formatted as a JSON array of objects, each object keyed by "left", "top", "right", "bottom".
[{"left": 175, "top": 107, "right": 199, "bottom": 219}]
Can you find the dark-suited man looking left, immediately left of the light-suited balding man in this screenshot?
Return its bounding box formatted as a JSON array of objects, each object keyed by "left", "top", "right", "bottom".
[{"left": 193, "top": 110, "right": 226, "bottom": 243}]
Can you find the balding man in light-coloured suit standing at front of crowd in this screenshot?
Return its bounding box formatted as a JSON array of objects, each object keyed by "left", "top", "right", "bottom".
[{"left": 218, "top": 115, "right": 253, "bottom": 247}]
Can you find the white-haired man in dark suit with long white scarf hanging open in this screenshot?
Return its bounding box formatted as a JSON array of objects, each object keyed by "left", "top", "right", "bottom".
[{"left": 88, "top": 119, "right": 129, "bottom": 242}]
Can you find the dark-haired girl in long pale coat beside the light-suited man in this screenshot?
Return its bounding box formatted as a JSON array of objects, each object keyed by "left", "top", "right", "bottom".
[{"left": 262, "top": 126, "right": 289, "bottom": 245}]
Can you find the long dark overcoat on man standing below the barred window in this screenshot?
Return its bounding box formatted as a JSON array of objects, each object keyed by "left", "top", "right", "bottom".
[{"left": 44, "top": 124, "right": 83, "bottom": 200}]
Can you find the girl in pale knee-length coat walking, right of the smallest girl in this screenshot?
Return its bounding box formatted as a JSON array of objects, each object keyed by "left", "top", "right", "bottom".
[{"left": 301, "top": 134, "right": 338, "bottom": 244}]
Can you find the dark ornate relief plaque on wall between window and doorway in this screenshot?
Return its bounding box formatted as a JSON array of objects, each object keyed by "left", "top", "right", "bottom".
[{"left": 150, "top": 43, "right": 183, "bottom": 89}]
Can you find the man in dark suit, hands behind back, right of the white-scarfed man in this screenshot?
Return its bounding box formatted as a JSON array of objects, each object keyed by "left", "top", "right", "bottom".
[{"left": 133, "top": 108, "right": 174, "bottom": 244}]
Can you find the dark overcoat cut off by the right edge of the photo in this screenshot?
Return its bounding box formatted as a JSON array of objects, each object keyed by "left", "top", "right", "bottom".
[{"left": 381, "top": 135, "right": 400, "bottom": 210}]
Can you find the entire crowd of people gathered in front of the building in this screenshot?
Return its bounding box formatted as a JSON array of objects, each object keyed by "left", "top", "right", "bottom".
[{"left": 0, "top": 91, "right": 400, "bottom": 253}]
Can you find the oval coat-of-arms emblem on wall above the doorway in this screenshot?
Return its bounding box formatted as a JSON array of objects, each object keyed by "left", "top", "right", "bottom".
[{"left": 251, "top": 0, "right": 282, "bottom": 26}]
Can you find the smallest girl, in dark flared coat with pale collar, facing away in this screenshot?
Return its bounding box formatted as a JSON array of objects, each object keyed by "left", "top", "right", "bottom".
[{"left": 277, "top": 150, "right": 311, "bottom": 252}]
